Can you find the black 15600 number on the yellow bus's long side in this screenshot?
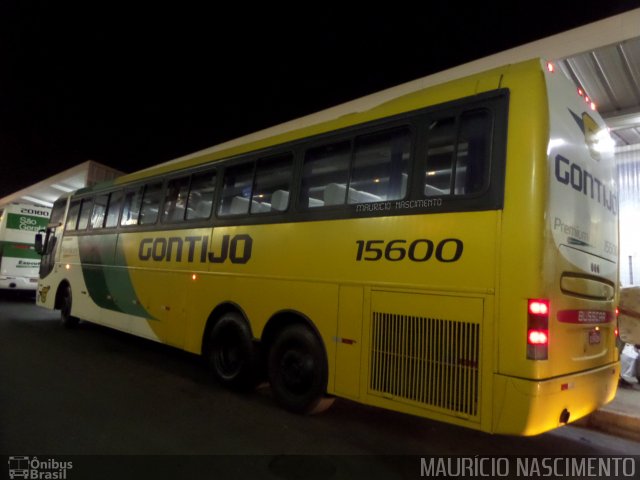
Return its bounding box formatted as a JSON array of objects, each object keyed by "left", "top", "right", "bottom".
[{"left": 356, "top": 238, "right": 464, "bottom": 263}]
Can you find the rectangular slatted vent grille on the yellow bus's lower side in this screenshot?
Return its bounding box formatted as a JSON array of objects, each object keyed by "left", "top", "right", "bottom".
[{"left": 369, "top": 312, "right": 480, "bottom": 417}]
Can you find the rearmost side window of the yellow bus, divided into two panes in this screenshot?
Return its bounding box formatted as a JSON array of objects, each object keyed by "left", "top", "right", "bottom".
[{"left": 424, "top": 110, "right": 491, "bottom": 197}]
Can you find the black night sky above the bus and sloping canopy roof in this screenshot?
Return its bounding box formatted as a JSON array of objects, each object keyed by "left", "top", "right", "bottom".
[{"left": 0, "top": 0, "right": 640, "bottom": 198}]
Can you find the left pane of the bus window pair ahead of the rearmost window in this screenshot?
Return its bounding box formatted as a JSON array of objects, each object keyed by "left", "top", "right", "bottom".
[{"left": 299, "top": 141, "right": 351, "bottom": 209}]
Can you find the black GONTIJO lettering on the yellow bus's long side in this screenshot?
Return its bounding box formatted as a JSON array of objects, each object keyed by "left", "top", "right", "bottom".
[{"left": 138, "top": 233, "right": 253, "bottom": 264}]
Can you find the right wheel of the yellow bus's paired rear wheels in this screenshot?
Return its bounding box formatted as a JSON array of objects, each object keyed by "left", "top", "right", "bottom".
[{"left": 268, "top": 324, "right": 332, "bottom": 414}]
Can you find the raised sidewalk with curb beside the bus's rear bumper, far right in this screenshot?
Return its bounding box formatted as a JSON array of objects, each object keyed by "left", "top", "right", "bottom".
[{"left": 576, "top": 383, "right": 640, "bottom": 442}]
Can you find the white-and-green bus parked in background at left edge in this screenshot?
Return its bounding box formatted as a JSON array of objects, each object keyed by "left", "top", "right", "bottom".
[{"left": 0, "top": 204, "right": 51, "bottom": 291}]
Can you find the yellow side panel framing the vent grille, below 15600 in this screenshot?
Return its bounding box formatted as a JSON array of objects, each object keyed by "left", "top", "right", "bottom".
[{"left": 361, "top": 289, "right": 493, "bottom": 429}]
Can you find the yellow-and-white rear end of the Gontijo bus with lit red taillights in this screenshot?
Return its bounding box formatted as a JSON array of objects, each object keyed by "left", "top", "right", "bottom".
[{"left": 494, "top": 60, "right": 619, "bottom": 434}]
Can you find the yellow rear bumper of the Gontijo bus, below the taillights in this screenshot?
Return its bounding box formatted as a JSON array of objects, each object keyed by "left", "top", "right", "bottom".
[{"left": 492, "top": 362, "right": 620, "bottom": 435}]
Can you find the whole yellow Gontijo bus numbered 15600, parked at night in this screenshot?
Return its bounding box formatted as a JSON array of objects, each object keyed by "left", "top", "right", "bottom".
[{"left": 37, "top": 59, "right": 619, "bottom": 435}]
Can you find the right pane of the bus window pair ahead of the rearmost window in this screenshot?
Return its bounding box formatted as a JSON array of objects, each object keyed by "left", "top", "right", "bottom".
[{"left": 348, "top": 128, "right": 411, "bottom": 204}]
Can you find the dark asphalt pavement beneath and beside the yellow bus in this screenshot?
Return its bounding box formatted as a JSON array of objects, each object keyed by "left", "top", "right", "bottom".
[{"left": 0, "top": 297, "right": 640, "bottom": 480}]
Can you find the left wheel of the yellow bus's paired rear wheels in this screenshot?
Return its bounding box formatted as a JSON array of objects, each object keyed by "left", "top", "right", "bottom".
[{"left": 207, "top": 312, "right": 259, "bottom": 390}]
